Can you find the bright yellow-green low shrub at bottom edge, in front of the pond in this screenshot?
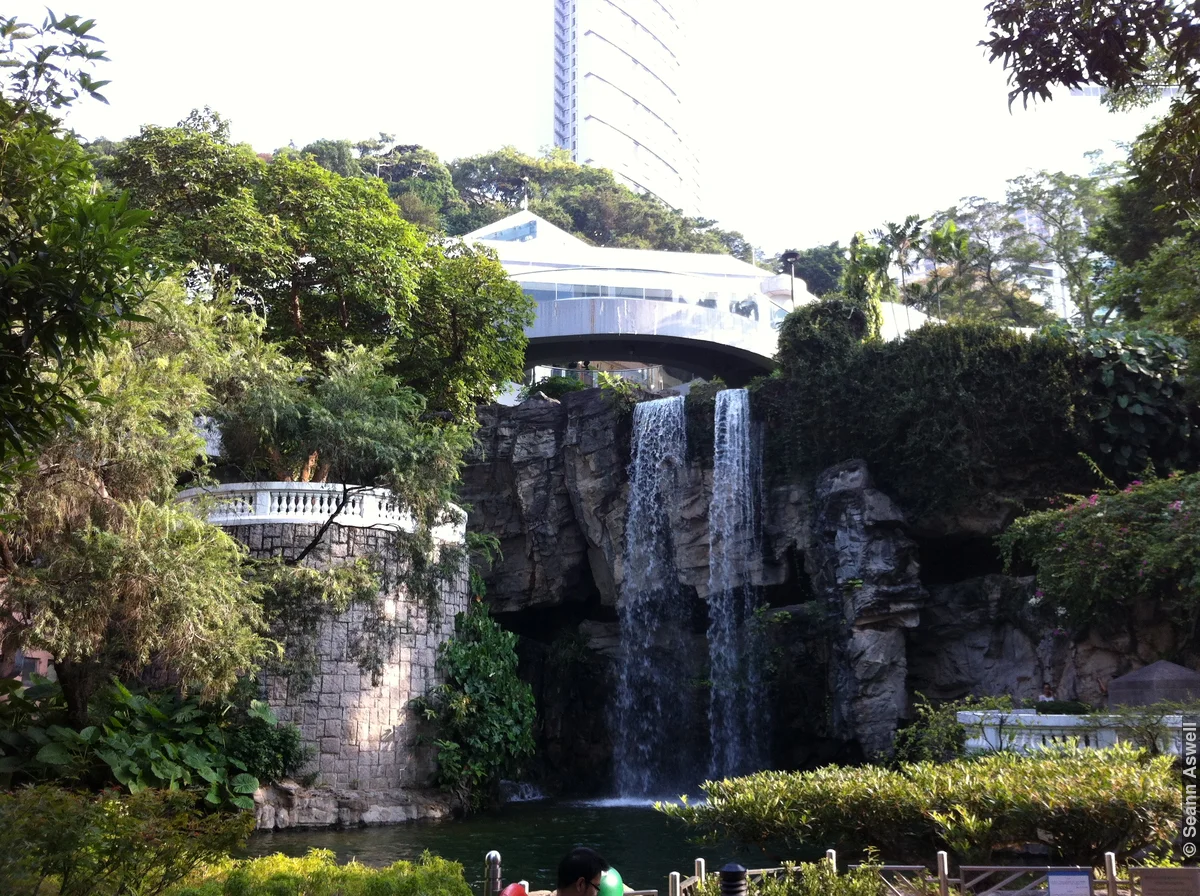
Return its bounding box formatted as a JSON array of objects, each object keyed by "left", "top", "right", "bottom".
[{"left": 172, "top": 849, "right": 470, "bottom": 896}]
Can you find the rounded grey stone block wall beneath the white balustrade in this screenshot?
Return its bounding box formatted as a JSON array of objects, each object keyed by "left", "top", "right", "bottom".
[{"left": 228, "top": 523, "right": 469, "bottom": 792}]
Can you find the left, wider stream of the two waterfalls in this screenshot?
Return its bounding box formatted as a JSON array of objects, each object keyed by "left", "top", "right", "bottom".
[{"left": 613, "top": 396, "right": 695, "bottom": 796}]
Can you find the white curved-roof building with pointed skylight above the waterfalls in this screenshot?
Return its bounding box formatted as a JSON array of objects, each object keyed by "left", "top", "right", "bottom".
[{"left": 463, "top": 210, "right": 940, "bottom": 386}]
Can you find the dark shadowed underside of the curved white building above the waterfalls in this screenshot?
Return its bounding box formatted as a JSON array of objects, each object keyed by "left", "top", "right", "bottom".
[{"left": 526, "top": 333, "right": 775, "bottom": 386}]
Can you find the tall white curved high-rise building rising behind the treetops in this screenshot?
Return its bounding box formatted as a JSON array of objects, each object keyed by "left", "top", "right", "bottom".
[{"left": 554, "top": 0, "right": 700, "bottom": 215}]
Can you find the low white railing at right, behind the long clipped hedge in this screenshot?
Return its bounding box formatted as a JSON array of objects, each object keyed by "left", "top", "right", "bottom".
[{"left": 958, "top": 709, "right": 1183, "bottom": 756}]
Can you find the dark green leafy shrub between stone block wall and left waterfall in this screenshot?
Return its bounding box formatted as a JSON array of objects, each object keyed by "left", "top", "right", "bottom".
[{"left": 415, "top": 601, "right": 534, "bottom": 811}]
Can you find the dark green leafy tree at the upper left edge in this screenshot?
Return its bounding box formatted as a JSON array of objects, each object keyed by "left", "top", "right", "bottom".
[{"left": 0, "top": 13, "right": 144, "bottom": 479}]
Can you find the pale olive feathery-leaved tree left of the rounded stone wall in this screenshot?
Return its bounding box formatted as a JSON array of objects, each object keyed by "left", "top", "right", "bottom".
[{"left": 0, "top": 283, "right": 265, "bottom": 724}]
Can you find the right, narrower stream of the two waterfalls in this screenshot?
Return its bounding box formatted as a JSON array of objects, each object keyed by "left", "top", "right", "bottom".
[{"left": 708, "top": 389, "right": 767, "bottom": 778}]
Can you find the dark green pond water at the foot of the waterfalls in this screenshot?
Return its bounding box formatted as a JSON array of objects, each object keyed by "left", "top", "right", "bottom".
[{"left": 246, "top": 800, "right": 763, "bottom": 894}]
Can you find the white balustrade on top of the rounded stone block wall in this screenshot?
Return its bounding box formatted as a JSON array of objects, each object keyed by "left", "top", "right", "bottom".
[{"left": 179, "top": 482, "right": 467, "bottom": 545}]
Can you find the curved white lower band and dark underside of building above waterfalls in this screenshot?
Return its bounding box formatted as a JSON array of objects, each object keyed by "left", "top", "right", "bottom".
[{"left": 526, "top": 297, "right": 776, "bottom": 385}]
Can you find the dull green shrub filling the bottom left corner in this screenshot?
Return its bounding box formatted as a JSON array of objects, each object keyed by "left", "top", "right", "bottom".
[{"left": 0, "top": 786, "right": 254, "bottom": 896}]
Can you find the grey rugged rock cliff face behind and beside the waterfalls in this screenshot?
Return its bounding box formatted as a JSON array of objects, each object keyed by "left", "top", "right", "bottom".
[{"left": 462, "top": 390, "right": 1172, "bottom": 793}]
